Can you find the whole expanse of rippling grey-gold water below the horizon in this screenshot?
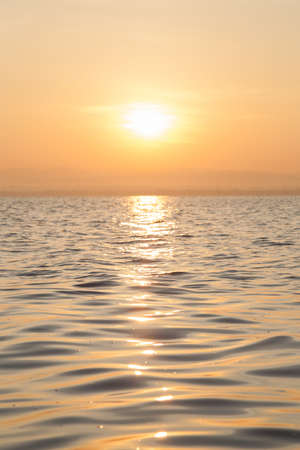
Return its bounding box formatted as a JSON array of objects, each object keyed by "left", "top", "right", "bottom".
[{"left": 0, "top": 197, "right": 300, "bottom": 450}]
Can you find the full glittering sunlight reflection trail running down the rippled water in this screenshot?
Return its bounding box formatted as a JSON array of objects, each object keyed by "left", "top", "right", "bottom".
[{"left": 122, "top": 196, "right": 179, "bottom": 428}]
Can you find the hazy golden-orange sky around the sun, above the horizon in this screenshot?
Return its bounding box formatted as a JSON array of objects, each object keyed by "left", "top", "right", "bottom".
[{"left": 0, "top": 0, "right": 300, "bottom": 189}]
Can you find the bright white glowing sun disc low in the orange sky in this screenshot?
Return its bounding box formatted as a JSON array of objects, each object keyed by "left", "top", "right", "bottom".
[{"left": 123, "top": 103, "right": 174, "bottom": 139}]
